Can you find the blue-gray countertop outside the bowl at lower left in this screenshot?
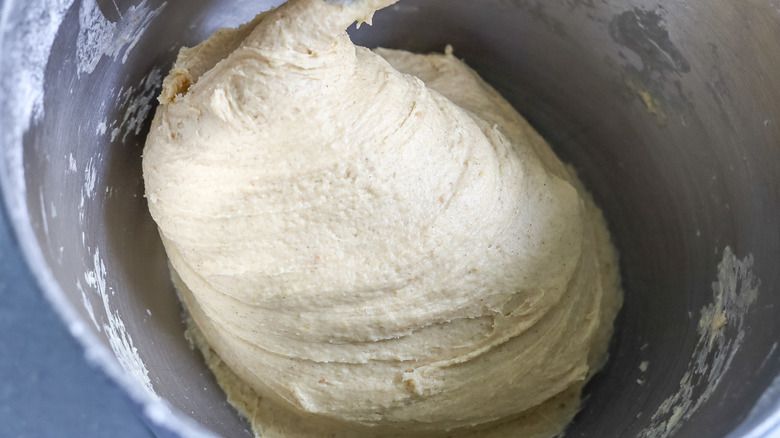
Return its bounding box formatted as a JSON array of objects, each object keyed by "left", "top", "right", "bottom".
[{"left": 0, "top": 203, "right": 153, "bottom": 438}]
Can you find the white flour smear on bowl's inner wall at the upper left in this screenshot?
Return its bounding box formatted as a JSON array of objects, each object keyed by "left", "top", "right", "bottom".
[{"left": 76, "top": 0, "right": 167, "bottom": 76}]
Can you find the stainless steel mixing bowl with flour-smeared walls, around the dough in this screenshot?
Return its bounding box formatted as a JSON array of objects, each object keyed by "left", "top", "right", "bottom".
[{"left": 0, "top": 0, "right": 780, "bottom": 437}]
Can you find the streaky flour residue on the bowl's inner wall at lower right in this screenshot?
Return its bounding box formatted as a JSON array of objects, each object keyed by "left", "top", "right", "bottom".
[{"left": 639, "top": 246, "right": 760, "bottom": 438}]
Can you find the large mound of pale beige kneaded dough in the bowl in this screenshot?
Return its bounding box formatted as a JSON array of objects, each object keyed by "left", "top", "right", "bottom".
[{"left": 143, "top": 0, "right": 621, "bottom": 436}]
